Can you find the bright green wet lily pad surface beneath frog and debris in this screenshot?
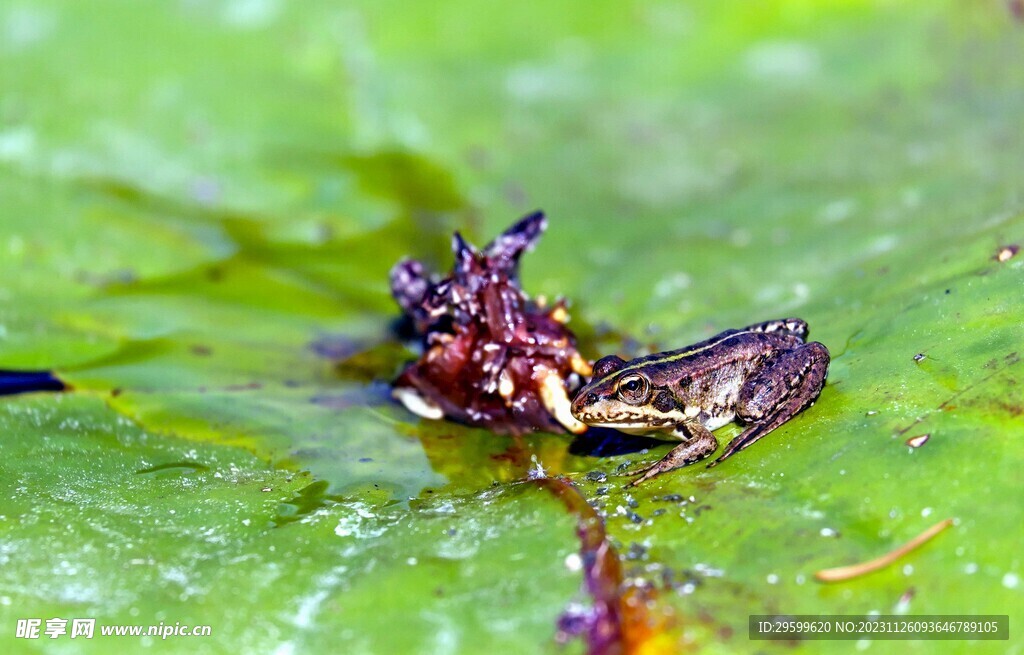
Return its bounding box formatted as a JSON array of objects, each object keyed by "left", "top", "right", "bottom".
[{"left": 0, "top": 0, "right": 1024, "bottom": 655}]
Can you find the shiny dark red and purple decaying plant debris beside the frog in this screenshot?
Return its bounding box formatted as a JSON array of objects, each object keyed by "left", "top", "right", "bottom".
[{"left": 391, "top": 212, "right": 591, "bottom": 434}]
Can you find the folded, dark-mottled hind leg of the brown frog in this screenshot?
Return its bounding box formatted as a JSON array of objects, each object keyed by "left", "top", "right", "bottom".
[{"left": 708, "top": 342, "right": 829, "bottom": 468}]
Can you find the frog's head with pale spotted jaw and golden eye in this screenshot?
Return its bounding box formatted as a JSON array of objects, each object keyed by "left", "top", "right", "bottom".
[{"left": 571, "top": 355, "right": 683, "bottom": 434}]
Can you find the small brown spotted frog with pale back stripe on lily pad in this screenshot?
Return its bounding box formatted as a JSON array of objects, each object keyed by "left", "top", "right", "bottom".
[{"left": 570, "top": 318, "right": 830, "bottom": 487}]
